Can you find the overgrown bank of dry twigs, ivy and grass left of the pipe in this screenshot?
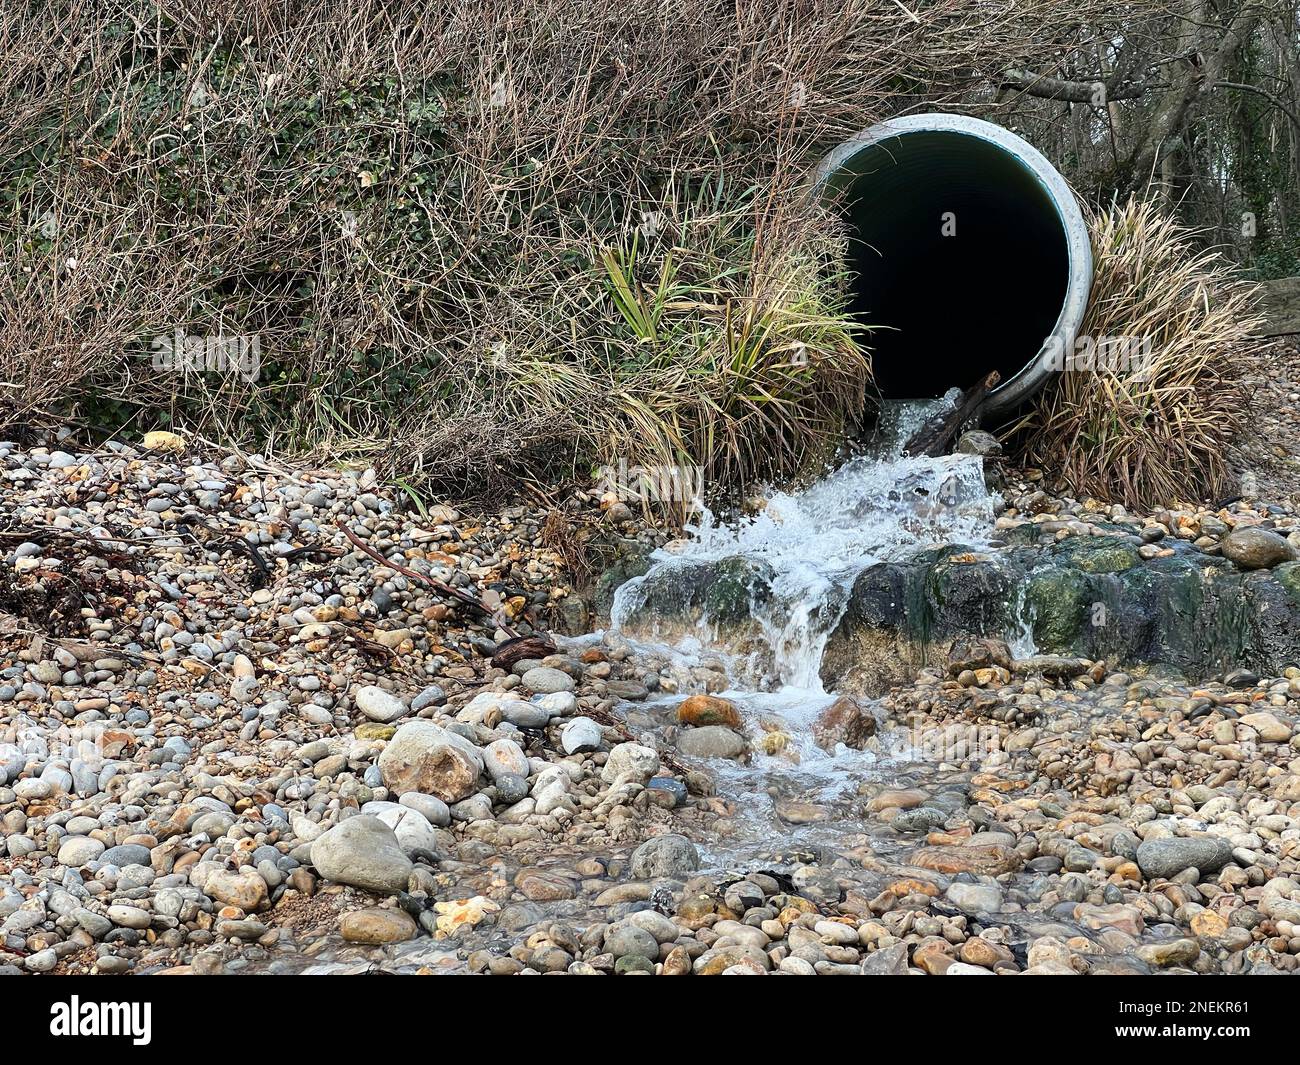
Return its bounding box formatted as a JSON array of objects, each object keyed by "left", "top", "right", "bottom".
[{"left": 0, "top": 0, "right": 1118, "bottom": 507}]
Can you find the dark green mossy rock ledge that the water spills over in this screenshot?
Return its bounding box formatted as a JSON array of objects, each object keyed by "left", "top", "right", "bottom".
[{"left": 621, "top": 536, "right": 1300, "bottom": 696}]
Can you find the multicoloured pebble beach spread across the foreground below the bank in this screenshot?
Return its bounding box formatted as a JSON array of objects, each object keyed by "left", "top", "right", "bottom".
[{"left": 0, "top": 429, "right": 1300, "bottom": 975}]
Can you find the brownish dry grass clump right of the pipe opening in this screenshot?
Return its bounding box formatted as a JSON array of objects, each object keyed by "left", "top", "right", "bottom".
[{"left": 1021, "top": 199, "right": 1258, "bottom": 507}]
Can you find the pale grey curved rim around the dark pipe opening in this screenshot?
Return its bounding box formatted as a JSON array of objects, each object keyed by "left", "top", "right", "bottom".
[{"left": 813, "top": 112, "right": 1092, "bottom": 415}]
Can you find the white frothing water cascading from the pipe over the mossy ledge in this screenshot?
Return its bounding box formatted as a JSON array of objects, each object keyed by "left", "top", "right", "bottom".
[{"left": 600, "top": 397, "right": 1032, "bottom": 863}]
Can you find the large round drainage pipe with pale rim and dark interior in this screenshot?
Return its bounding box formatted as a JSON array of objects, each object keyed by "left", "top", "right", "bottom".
[{"left": 816, "top": 114, "right": 1092, "bottom": 415}]
